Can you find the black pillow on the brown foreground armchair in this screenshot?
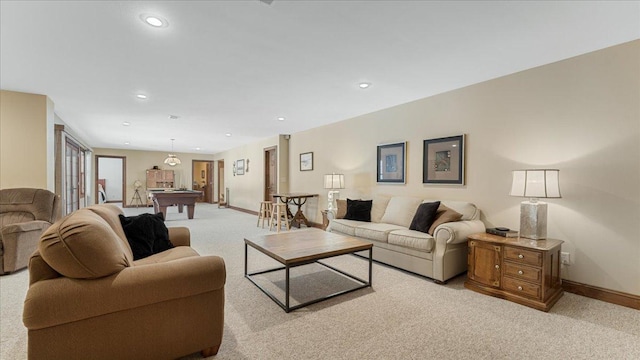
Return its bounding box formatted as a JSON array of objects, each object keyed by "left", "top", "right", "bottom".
[{"left": 119, "top": 213, "right": 173, "bottom": 260}]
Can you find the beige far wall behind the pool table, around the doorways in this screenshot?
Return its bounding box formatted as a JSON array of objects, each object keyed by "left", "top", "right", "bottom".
[{"left": 91, "top": 148, "right": 215, "bottom": 204}]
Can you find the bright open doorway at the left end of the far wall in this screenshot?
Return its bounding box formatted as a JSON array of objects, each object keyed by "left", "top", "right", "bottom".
[{"left": 95, "top": 155, "right": 127, "bottom": 207}]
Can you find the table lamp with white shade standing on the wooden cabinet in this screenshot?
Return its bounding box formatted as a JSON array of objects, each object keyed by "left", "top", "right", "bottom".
[{"left": 509, "top": 169, "right": 561, "bottom": 240}]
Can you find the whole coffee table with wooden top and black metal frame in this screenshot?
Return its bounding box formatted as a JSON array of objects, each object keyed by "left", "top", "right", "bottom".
[{"left": 244, "top": 228, "right": 373, "bottom": 312}]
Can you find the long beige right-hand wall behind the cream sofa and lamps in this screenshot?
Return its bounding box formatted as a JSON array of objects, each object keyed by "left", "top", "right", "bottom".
[{"left": 222, "top": 41, "right": 640, "bottom": 295}]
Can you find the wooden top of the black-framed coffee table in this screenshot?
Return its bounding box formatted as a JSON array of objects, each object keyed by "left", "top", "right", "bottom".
[{"left": 244, "top": 228, "right": 373, "bottom": 265}]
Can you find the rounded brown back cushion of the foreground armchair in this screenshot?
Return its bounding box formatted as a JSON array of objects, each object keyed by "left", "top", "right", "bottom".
[{"left": 38, "top": 209, "right": 131, "bottom": 279}]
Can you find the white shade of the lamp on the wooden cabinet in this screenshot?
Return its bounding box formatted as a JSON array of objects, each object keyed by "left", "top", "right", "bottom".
[{"left": 509, "top": 169, "right": 561, "bottom": 198}]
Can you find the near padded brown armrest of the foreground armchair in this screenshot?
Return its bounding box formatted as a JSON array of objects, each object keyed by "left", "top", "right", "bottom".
[{"left": 23, "top": 256, "right": 226, "bottom": 330}]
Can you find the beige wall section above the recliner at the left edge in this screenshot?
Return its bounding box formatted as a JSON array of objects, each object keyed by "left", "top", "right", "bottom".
[{"left": 0, "top": 90, "right": 55, "bottom": 191}]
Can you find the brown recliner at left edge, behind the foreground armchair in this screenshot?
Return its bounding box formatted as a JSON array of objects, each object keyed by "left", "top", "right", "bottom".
[{"left": 0, "top": 188, "right": 60, "bottom": 275}]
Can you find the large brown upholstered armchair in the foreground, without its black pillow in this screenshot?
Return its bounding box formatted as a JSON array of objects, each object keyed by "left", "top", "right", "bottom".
[{"left": 23, "top": 204, "right": 226, "bottom": 360}]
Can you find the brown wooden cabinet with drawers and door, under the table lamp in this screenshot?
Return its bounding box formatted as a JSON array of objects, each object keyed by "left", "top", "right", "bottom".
[{"left": 464, "top": 233, "right": 563, "bottom": 311}]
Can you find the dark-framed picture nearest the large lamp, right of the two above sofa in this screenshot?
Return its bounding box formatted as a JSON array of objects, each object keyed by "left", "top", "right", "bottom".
[{"left": 422, "top": 135, "right": 465, "bottom": 185}]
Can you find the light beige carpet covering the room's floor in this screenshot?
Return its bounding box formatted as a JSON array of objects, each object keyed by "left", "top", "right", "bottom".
[{"left": 0, "top": 204, "right": 640, "bottom": 359}]
